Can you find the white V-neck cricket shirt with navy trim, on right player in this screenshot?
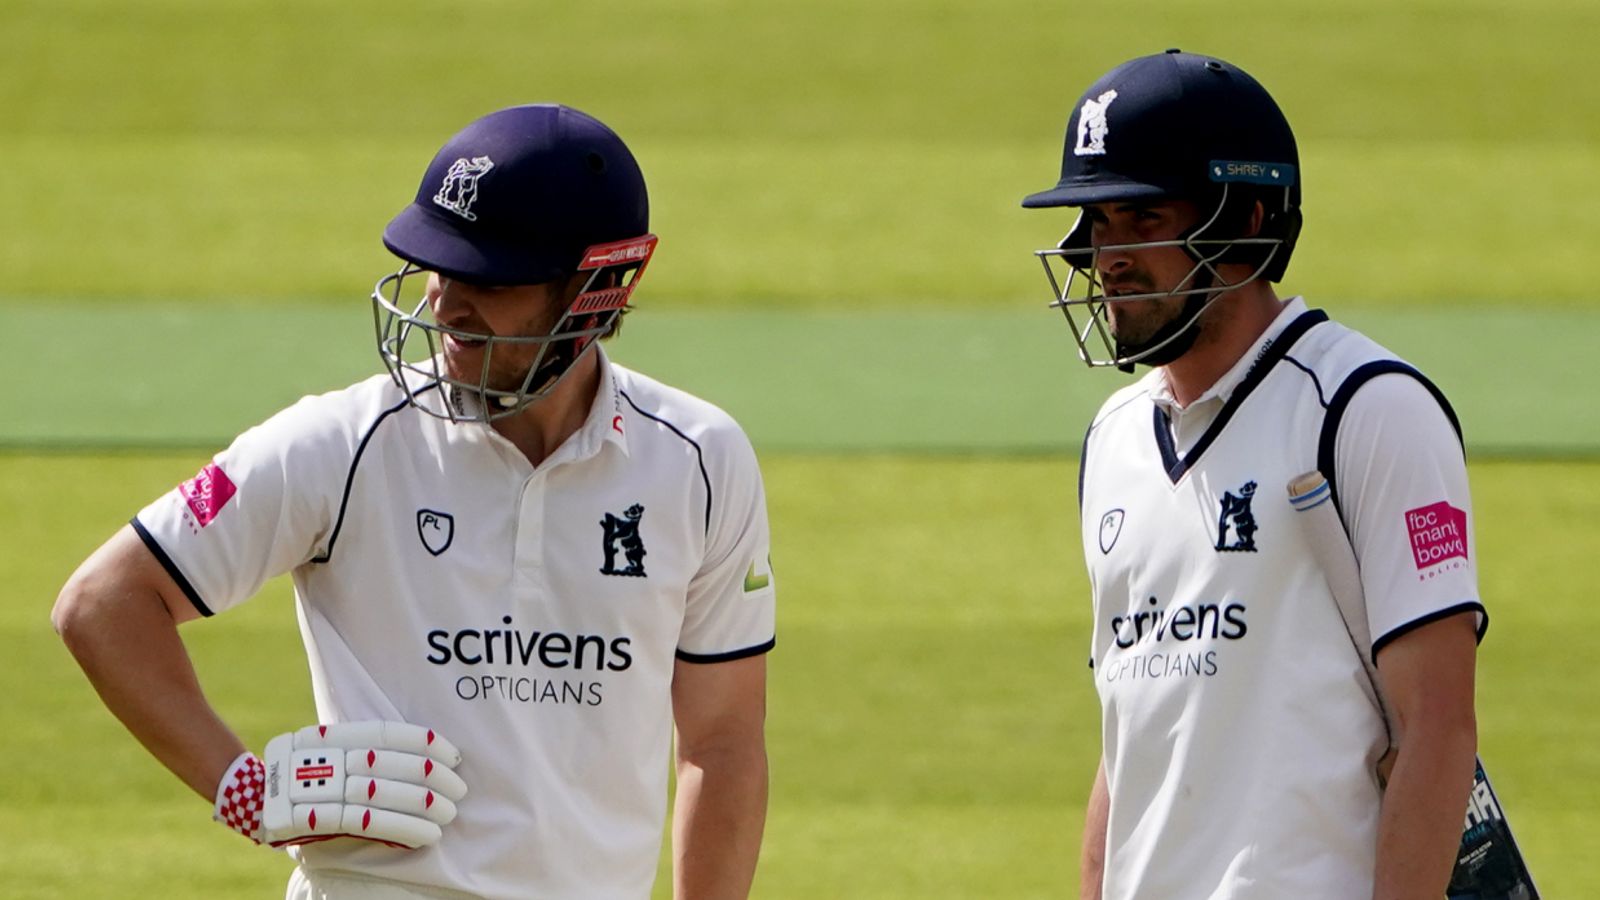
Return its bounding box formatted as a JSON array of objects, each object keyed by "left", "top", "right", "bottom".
[{"left": 1080, "top": 298, "right": 1486, "bottom": 900}]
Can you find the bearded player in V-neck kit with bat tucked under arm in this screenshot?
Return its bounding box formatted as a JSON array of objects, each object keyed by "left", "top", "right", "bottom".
[{"left": 1024, "top": 51, "right": 1486, "bottom": 900}]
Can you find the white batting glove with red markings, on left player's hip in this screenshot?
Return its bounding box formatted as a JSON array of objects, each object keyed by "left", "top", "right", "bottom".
[{"left": 213, "top": 722, "right": 467, "bottom": 850}]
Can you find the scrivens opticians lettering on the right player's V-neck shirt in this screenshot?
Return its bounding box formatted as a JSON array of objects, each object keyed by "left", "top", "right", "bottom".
[{"left": 1101, "top": 597, "right": 1250, "bottom": 682}]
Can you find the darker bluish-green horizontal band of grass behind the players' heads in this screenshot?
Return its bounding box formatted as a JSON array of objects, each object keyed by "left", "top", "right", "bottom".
[{"left": 0, "top": 301, "right": 1600, "bottom": 458}]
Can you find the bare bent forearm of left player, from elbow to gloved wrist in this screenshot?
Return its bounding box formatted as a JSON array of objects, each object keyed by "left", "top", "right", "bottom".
[{"left": 53, "top": 573, "right": 245, "bottom": 791}]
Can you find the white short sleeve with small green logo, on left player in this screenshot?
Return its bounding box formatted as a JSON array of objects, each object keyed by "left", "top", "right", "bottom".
[{"left": 677, "top": 421, "right": 778, "bottom": 663}]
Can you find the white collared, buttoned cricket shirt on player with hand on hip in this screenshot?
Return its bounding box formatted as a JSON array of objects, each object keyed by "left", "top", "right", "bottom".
[{"left": 133, "top": 349, "right": 774, "bottom": 898}]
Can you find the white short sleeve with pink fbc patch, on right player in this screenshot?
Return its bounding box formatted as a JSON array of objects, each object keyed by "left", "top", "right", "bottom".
[{"left": 1334, "top": 372, "right": 1488, "bottom": 658}]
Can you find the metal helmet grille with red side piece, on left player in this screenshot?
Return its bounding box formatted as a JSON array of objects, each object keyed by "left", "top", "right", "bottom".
[{"left": 371, "top": 235, "right": 656, "bottom": 423}]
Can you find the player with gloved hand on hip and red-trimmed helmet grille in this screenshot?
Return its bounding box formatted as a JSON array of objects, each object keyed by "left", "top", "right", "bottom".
[{"left": 54, "top": 106, "right": 774, "bottom": 900}]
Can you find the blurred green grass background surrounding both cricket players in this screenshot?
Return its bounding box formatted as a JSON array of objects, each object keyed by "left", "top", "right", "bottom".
[{"left": 0, "top": 0, "right": 1600, "bottom": 898}]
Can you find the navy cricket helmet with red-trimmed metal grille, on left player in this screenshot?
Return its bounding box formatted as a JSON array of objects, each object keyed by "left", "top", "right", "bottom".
[{"left": 373, "top": 104, "right": 656, "bottom": 421}]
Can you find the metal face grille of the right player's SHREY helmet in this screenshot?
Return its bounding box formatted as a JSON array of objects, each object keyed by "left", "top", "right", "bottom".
[{"left": 1034, "top": 186, "right": 1285, "bottom": 368}]
